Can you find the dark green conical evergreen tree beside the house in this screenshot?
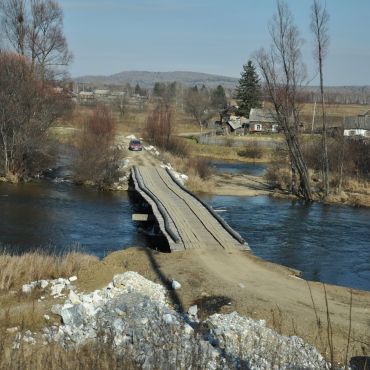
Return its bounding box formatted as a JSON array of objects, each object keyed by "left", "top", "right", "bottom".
[{"left": 235, "top": 60, "right": 261, "bottom": 118}]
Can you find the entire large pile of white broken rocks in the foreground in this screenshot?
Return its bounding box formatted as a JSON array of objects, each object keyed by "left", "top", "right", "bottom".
[{"left": 28, "top": 272, "right": 328, "bottom": 369}]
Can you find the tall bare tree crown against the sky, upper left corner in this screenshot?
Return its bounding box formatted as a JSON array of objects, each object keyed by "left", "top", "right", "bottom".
[{"left": 0, "top": 0, "right": 72, "bottom": 80}]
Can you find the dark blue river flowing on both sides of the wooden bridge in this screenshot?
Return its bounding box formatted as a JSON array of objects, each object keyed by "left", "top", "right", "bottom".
[{"left": 0, "top": 162, "right": 370, "bottom": 291}]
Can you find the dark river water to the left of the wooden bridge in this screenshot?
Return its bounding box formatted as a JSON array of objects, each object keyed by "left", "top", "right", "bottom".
[{"left": 0, "top": 182, "right": 165, "bottom": 257}]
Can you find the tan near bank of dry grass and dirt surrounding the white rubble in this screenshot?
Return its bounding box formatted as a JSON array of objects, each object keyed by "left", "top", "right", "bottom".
[{"left": 0, "top": 248, "right": 370, "bottom": 370}]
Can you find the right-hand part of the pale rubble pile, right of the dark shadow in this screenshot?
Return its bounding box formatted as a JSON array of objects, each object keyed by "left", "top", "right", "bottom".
[{"left": 206, "top": 312, "right": 329, "bottom": 370}]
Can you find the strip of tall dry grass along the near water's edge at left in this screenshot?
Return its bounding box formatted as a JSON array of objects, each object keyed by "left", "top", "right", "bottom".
[{"left": 0, "top": 252, "right": 99, "bottom": 291}]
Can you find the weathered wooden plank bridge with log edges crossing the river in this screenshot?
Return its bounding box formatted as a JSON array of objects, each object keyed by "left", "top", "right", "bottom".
[{"left": 131, "top": 166, "right": 249, "bottom": 250}]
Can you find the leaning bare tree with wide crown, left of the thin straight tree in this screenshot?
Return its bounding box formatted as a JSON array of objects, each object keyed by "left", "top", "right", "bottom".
[{"left": 255, "top": 1, "right": 312, "bottom": 201}]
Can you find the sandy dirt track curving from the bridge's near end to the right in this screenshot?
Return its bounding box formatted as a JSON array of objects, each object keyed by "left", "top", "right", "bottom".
[{"left": 72, "top": 248, "right": 370, "bottom": 359}]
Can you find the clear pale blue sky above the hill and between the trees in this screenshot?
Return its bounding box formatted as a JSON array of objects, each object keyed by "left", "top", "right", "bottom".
[{"left": 59, "top": 0, "right": 370, "bottom": 85}]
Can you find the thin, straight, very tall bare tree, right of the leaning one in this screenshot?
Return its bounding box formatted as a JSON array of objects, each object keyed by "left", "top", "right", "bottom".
[{"left": 311, "top": 0, "right": 330, "bottom": 196}]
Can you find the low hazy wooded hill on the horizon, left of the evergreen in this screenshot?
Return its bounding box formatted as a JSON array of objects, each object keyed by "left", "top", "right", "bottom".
[{"left": 74, "top": 71, "right": 238, "bottom": 88}]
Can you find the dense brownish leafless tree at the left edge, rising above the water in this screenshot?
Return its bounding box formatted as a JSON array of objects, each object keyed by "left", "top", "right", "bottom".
[{"left": 0, "top": 53, "right": 69, "bottom": 179}]
